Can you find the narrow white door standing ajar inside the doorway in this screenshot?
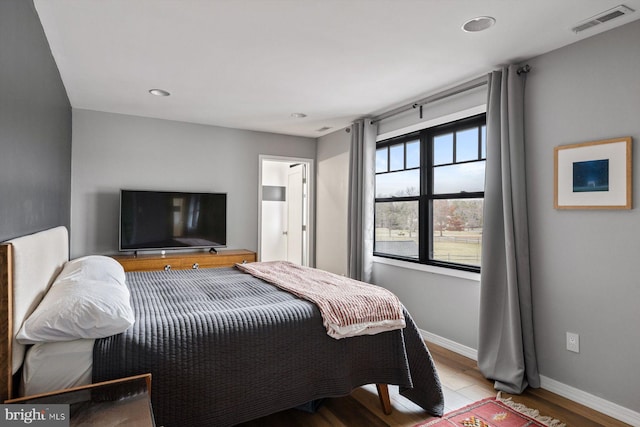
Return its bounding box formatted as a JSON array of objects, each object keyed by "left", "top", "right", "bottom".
[{"left": 287, "top": 164, "right": 306, "bottom": 265}]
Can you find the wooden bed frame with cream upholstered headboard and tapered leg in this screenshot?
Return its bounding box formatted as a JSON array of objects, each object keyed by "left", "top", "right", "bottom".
[{"left": 0, "top": 227, "right": 392, "bottom": 415}]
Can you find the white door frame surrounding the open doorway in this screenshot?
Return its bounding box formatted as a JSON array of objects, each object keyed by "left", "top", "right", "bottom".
[{"left": 257, "top": 154, "right": 316, "bottom": 267}]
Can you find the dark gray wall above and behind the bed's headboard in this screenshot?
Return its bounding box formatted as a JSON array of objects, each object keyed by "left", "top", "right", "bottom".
[{"left": 0, "top": 0, "right": 71, "bottom": 241}]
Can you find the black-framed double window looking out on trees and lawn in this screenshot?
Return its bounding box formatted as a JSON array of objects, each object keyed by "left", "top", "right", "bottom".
[{"left": 374, "top": 114, "right": 486, "bottom": 271}]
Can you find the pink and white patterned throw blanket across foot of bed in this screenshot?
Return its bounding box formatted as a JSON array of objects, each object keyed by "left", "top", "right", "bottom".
[{"left": 236, "top": 261, "right": 405, "bottom": 339}]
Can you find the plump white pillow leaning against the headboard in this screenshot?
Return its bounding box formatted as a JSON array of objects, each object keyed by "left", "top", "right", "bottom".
[{"left": 16, "top": 255, "right": 134, "bottom": 344}]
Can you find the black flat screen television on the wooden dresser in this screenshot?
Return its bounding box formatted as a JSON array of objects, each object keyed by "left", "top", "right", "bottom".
[{"left": 119, "top": 190, "right": 227, "bottom": 251}]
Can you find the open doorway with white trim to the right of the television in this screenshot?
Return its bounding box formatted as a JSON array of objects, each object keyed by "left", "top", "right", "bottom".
[{"left": 258, "top": 156, "right": 313, "bottom": 266}]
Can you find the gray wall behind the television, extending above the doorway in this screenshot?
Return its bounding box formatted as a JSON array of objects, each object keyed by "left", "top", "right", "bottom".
[{"left": 71, "top": 109, "right": 316, "bottom": 257}]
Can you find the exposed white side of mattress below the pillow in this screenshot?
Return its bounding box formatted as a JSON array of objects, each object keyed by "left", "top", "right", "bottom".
[{"left": 20, "top": 339, "right": 95, "bottom": 396}]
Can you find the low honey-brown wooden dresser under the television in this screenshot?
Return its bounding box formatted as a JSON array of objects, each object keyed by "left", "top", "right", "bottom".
[{"left": 113, "top": 249, "right": 256, "bottom": 271}]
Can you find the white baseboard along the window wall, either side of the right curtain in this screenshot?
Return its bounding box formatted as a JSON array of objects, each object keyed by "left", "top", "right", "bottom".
[{"left": 420, "top": 329, "right": 640, "bottom": 426}]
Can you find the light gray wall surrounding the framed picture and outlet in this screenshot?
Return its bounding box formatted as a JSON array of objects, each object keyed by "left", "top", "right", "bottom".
[{"left": 525, "top": 21, "right": 640, "bottom": 412}]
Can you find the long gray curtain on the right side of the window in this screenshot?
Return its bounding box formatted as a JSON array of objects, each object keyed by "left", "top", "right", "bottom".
[{"left": 478, "top": 66, "right": 540, "bottom": 394}]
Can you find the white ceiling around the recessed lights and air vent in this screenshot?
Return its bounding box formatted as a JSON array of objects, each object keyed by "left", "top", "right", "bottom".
[{"left": 34, "top": 0, "right": 640, "bottom": 137}]
